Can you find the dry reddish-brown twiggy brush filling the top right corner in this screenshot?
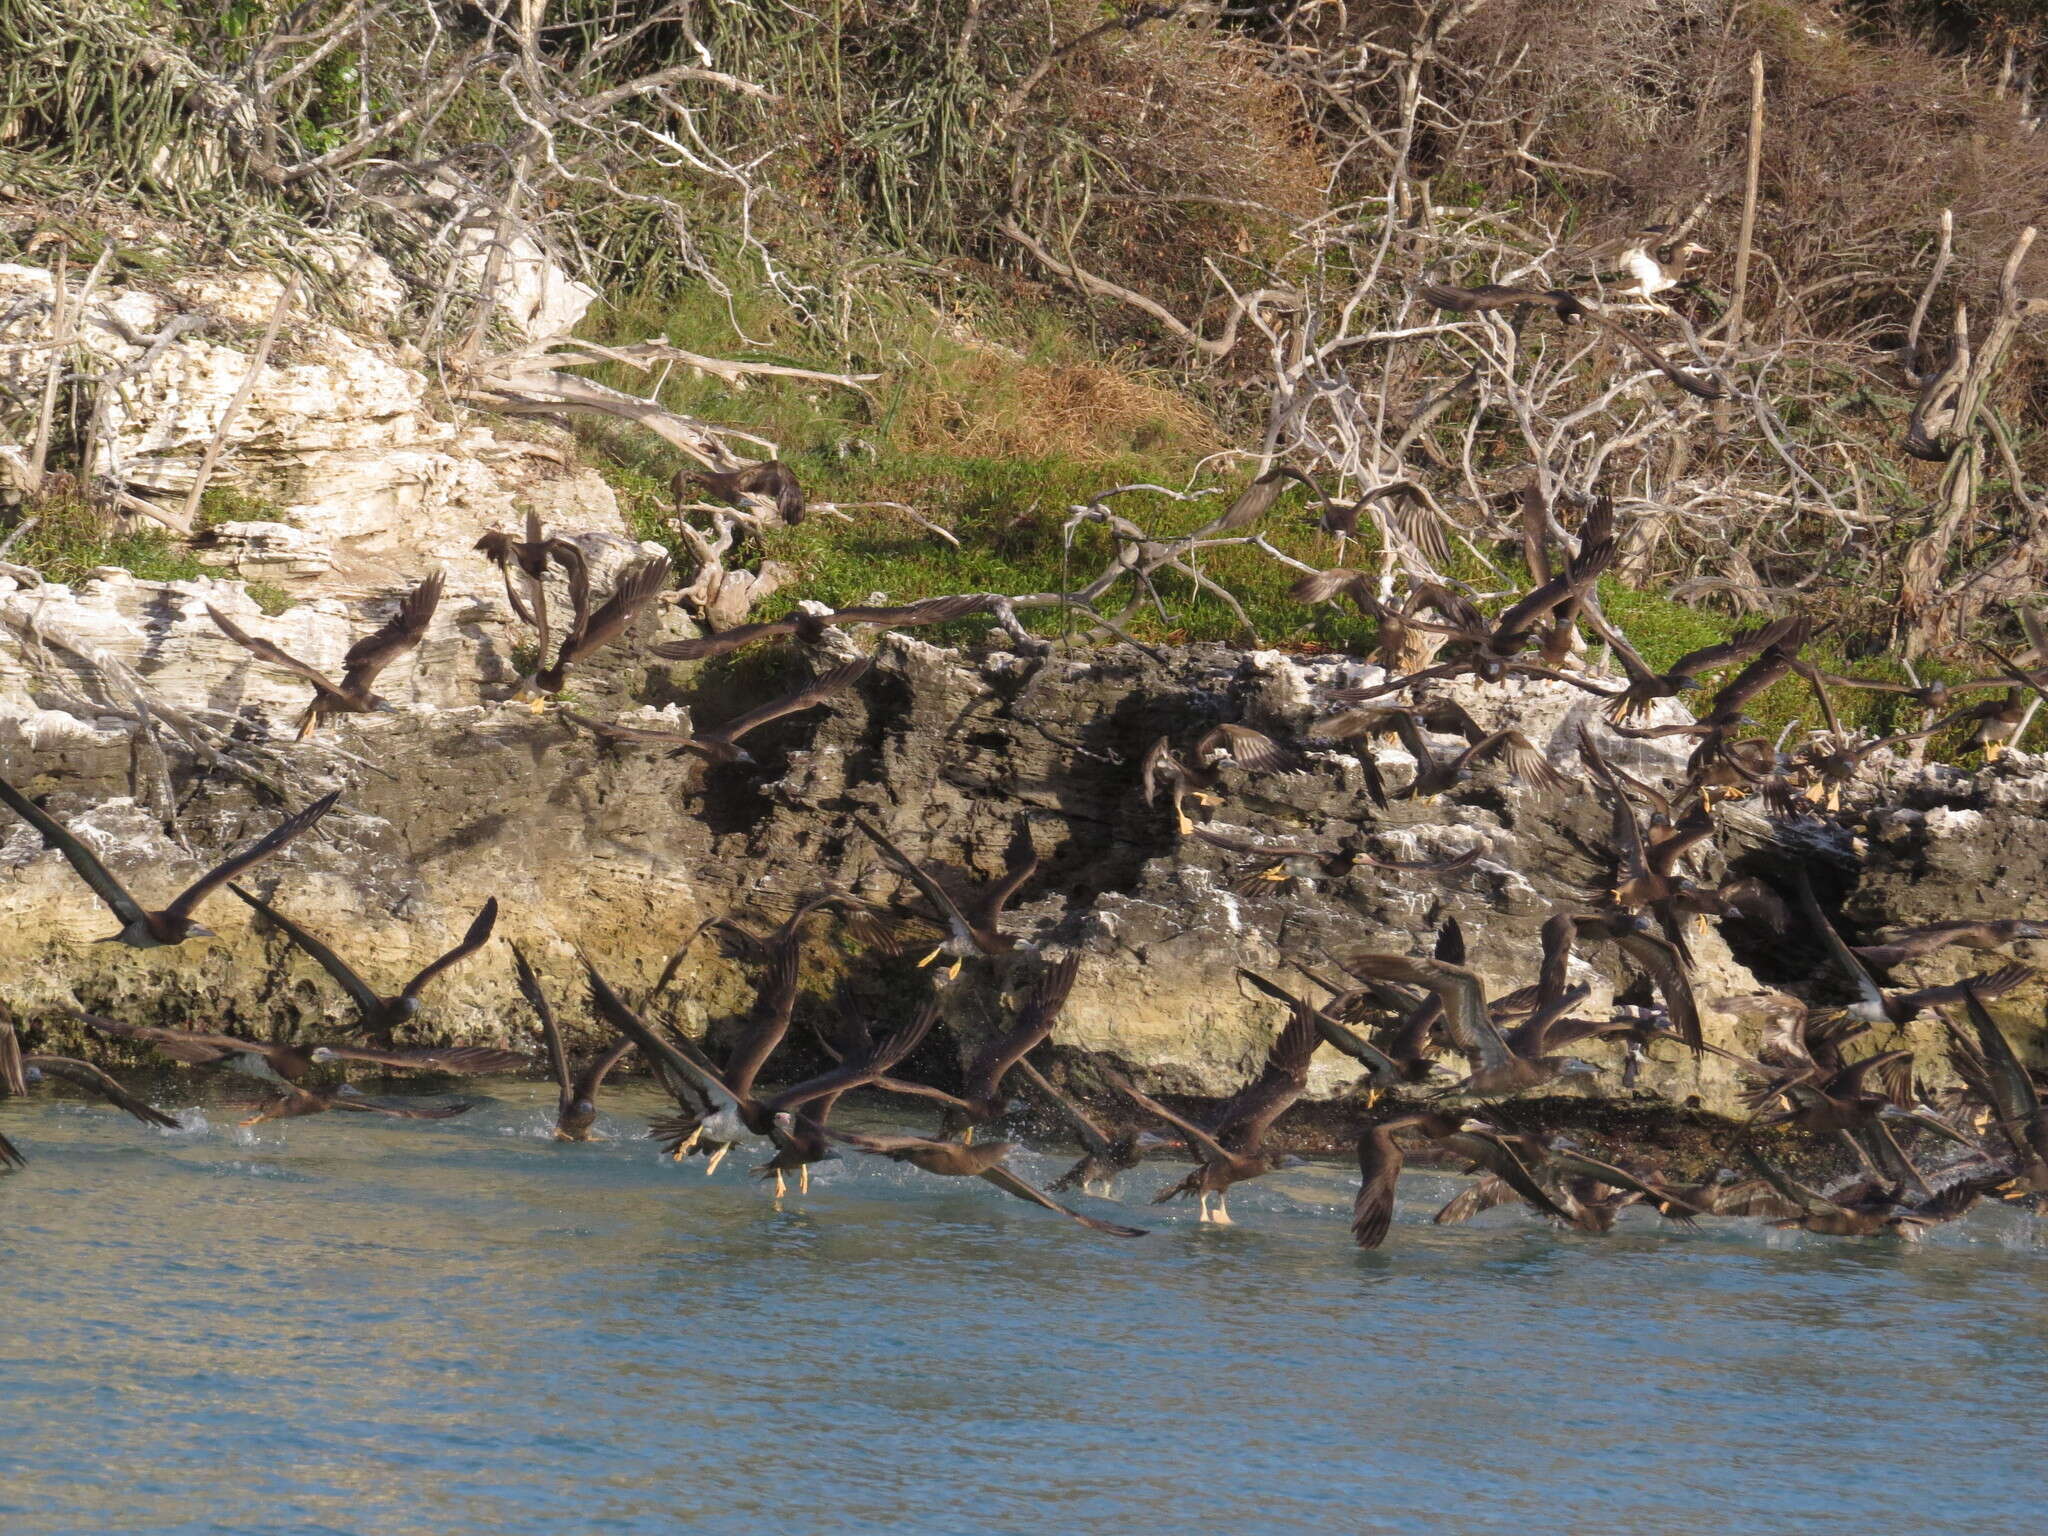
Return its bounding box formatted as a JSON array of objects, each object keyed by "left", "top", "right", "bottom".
[{"left": 1436, "top": 0, "right": 2048, "bottom": 340}]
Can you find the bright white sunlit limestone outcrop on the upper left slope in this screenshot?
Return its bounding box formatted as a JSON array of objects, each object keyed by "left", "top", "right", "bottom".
[{"left": 0, "top": 262, "right": 627, "bottom": 598}]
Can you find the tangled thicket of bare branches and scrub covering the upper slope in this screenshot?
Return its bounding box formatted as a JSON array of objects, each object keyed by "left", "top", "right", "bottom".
[{"left": 0, "top": 0, "right": 2048, "bottom": 667}]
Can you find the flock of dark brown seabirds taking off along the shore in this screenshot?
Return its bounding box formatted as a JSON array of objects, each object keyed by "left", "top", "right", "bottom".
[{"left": 0, "top": 417, "right": 2048, "bottom": 1247}]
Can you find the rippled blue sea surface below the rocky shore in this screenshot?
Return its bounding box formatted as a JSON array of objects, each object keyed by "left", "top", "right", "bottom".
[{"left": 0, "top": 1083, "right": 2048, "bottom": 1536}]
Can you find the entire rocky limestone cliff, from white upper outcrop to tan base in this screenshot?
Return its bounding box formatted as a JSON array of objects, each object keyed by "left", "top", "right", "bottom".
[{"left": 0, "top": 256, "right": 2048, "bottom": 1110}]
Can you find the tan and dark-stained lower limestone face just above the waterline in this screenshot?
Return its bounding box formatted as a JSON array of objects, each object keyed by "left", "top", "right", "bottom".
[{"left": 0, "top": 630, "right": 1757, "bottom": 1104}]
